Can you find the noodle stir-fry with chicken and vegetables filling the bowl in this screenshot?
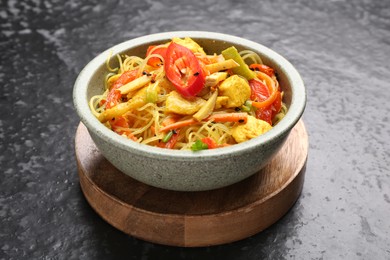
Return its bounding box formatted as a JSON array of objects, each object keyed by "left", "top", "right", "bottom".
[{"left": 89, "top": 37, "right": 287, "bottom": 151}]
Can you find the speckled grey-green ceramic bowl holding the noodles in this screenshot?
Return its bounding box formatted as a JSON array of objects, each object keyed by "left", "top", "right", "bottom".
[{"left": 73, "top": 31, "right": 306, "bottom": 191}]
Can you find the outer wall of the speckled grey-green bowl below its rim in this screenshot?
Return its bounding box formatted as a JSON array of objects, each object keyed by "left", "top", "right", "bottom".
[{"left": 89, "top": 128, "right": 289, "bottom": 191}]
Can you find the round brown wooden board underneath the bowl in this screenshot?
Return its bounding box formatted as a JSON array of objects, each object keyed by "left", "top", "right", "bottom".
[{"left": 75, "top": 120, "right": 308, "bottom": 247}]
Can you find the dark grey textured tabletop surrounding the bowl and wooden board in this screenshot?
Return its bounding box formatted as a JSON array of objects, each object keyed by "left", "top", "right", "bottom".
[{"left": 0, "top": 0, "right": 390, "bottom": 259}]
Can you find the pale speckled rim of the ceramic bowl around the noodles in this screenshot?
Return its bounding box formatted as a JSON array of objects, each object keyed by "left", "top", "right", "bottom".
[{"left": 73, "top": 31, "right": 306, "bottom": 160}]
